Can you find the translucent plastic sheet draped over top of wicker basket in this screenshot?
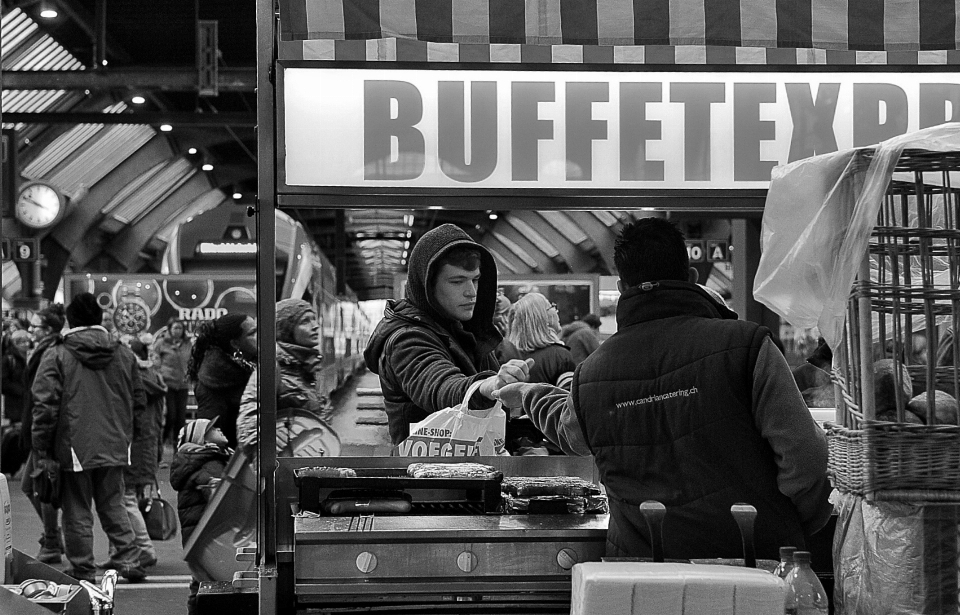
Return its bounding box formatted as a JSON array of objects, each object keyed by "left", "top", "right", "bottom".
[{"left": 753, "top": 122, "right": 960, "bottom": 348}]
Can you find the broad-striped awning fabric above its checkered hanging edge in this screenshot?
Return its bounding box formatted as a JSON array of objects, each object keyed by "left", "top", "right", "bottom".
[{"left": 280, "top": 0, "right": 960, "bottom": 52}]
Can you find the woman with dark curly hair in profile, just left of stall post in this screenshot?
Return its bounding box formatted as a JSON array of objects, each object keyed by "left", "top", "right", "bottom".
[{"left": 187, "top": 313, "right": 257, "bottom": 448}]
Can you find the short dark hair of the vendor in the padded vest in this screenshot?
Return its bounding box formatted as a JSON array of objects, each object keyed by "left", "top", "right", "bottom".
[{"left": 613, "top": 218, "right": 690, "bottom": 288}]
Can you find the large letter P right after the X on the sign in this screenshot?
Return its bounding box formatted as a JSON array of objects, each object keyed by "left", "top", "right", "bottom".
[{"left": 853, "top": 83, "right": 907, "bottom": 147}]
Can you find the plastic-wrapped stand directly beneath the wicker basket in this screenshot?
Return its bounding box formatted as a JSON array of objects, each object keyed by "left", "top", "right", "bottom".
[{"left": 833, "top": 493, "right": 960, "bottom": 615}]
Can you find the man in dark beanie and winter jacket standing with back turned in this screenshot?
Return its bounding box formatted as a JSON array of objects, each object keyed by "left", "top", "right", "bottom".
[{"left": 31, "top": 293, "right": 145, "bottom": 581}]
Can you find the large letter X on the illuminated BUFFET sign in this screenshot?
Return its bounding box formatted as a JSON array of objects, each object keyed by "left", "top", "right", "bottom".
[{"left": 785, "top": 83, "right": 840, "bottom": 162}]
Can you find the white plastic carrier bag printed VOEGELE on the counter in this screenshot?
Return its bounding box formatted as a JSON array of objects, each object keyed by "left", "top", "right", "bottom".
[{"left": 397, "top": 380, "right": 507, "bottom": 457}]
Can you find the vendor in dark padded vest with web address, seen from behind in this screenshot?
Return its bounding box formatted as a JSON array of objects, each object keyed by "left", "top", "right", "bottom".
[{"left": 498, "top": 218, "right": 832, "bottom": 559}]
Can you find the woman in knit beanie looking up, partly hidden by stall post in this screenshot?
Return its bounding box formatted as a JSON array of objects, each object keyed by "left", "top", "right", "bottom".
[{"left": 237, "top": 299, "right": 339, "bottom": 457}]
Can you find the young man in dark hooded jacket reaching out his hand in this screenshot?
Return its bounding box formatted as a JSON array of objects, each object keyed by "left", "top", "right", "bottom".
[{"left": 363, "top": 224, "right": 529, "bottom": 444}]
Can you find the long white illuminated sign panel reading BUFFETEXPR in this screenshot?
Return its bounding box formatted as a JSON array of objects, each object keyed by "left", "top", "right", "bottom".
[{"left": 280, "top": 68, "right": 960, "bottom": 190}]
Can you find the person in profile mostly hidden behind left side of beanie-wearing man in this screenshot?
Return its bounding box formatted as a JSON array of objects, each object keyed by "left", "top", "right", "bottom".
[{"left": 20, "top": 303, "right": 67, "bottom": 564}]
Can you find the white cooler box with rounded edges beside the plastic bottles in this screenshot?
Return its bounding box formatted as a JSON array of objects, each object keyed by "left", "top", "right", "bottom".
[{"left": 570, "top": 562, "right": 784, "bottom": 615}]
